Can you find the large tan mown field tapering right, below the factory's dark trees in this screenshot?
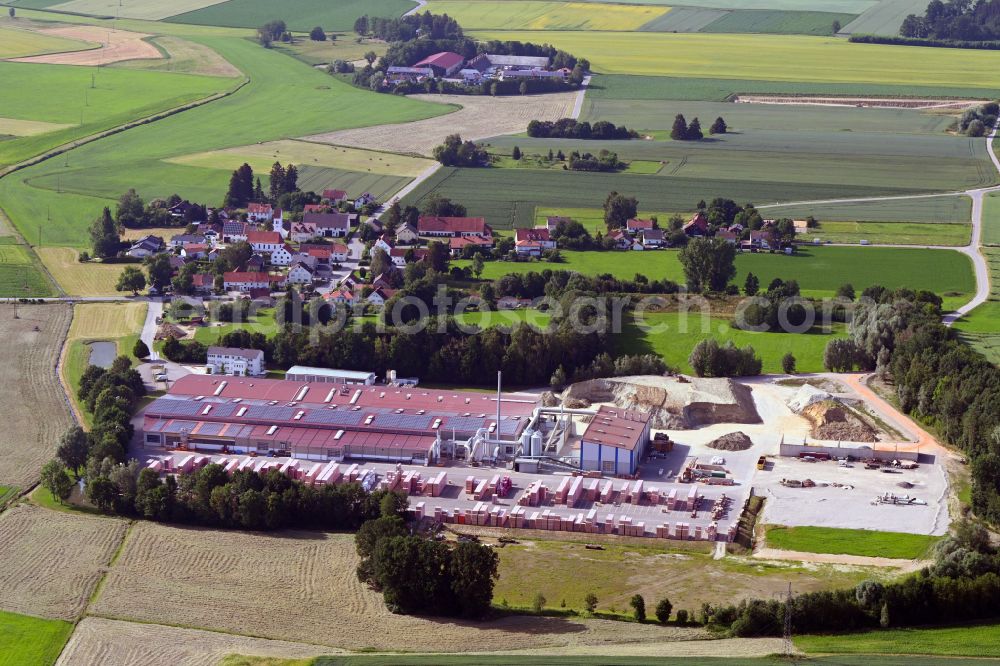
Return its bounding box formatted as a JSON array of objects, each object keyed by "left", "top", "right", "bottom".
[{"left": 91, "top": 522, "right": 705, "bottom": 652}]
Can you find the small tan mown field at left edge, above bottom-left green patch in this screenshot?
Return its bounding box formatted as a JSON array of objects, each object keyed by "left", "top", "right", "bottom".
[{"left": 0, "top": 503, "right": 128, "bottom": 620}]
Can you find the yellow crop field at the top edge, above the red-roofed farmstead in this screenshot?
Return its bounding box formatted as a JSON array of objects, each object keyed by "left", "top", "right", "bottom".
[{"left": 421, "top": 0, "right": 669, "bottom": 31}]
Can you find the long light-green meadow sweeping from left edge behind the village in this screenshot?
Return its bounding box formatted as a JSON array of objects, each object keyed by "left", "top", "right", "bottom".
[{"left": 0, "top": 26, "right": 441, "bottom": 254}]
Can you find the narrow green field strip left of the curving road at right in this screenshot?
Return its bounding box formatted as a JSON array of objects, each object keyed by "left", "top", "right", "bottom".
[{"left": 796, "top": 222, "right": 972, "bottom": 247}]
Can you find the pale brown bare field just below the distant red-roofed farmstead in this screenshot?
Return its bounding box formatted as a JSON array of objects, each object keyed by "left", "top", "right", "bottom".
[{"left": 307, "top": 92, "right": 576, "bottom": 155}]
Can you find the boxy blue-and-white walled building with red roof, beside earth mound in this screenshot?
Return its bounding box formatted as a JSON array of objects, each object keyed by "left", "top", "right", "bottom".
[{"left": 580, "top": 405, "right": 651, "bottom": 476}]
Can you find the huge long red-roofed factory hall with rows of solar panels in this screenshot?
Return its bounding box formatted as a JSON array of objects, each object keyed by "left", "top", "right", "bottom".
[{"left": 141, "top": 375, "right": 538, "bottom": 463}]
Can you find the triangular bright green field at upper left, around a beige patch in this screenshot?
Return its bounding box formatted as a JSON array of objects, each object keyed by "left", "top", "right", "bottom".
[{"left": 0, "top": 62, "right": 234, "bottom": 167}]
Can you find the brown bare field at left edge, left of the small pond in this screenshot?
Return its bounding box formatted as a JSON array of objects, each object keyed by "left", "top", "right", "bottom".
[{"left": 0, "top": 304, "right": 72, "bottom": 486}]
